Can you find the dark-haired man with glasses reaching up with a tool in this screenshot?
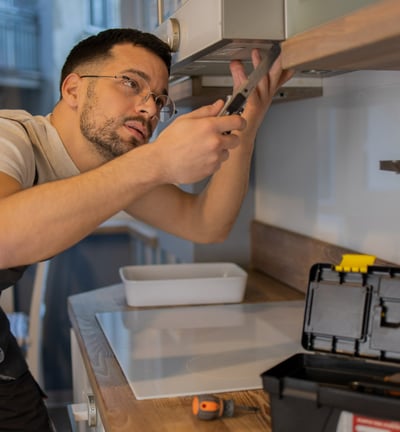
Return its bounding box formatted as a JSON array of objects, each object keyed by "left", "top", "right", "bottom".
[{"left": 0, "top": 29, "right": 291, "bottom": 432}]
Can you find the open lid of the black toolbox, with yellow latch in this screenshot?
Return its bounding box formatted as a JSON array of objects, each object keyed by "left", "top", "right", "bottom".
[{"left": 302, "top": 255, "right": 400, "bottom": 362}]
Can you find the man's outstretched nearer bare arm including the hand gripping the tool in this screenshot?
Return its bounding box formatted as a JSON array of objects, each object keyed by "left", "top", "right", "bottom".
[{"left": 0, "top": 103, "right": 245, "bottom": 268}]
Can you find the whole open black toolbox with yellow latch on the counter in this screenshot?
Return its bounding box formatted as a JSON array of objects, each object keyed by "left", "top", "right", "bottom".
[{"left": 261, "top": 256, "right": 400, "bottom": 432}]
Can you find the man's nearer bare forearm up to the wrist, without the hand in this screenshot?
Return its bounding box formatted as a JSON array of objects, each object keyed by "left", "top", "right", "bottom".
[{"left": 0, "top": 148, "right": 160, "bottom": 268}]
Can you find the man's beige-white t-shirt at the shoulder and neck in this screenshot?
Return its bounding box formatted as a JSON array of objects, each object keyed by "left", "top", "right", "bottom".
[{"left": 0, "top": 110, "right": 79, "bottom": 189}]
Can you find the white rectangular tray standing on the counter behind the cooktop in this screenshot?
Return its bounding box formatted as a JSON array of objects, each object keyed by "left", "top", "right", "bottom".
[{"left": 119, "top": 263, "right": 247, "bottom": 306}]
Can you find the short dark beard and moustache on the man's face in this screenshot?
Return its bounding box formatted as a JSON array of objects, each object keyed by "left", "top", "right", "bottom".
[{"left": 80, "top": 86, "right": 152, "bottom": 161}]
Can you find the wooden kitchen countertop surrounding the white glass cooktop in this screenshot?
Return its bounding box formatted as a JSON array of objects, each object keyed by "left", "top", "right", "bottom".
[{"left": 68, "top": 271, "right": 304, "bottom": 432}]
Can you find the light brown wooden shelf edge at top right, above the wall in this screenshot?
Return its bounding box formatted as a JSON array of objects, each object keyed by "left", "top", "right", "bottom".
[{"left": 282, "top": 0, "right": 400, "bottom": 71}]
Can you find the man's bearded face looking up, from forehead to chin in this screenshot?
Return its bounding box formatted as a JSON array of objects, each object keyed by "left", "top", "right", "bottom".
[{"left": 80, "top": 44, "right": 168, "bottom": 160}]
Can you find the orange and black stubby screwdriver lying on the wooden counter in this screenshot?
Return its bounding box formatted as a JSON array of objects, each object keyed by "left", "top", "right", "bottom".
[{"left": 192, "top": 394, "right": 259, "bottom": 420}]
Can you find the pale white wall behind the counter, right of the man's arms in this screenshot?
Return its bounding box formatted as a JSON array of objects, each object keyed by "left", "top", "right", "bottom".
[{"left": 255, "top": 71, "right": 400, "bottom": 263}]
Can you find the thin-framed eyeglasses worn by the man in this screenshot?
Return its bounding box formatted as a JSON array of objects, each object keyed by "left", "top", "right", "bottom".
[{"left": 80, "top": 71, "right": 176, "bottom": 122}]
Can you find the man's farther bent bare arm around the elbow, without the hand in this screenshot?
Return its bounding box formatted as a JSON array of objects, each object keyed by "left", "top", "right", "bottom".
[{"left": 127, "top": 129, "right": 253, "bottom": 243}]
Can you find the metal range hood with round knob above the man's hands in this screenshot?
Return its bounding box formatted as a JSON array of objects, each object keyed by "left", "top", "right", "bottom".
[{"left": 154, "top": 0, "right": 322, "bottom": 106}]
